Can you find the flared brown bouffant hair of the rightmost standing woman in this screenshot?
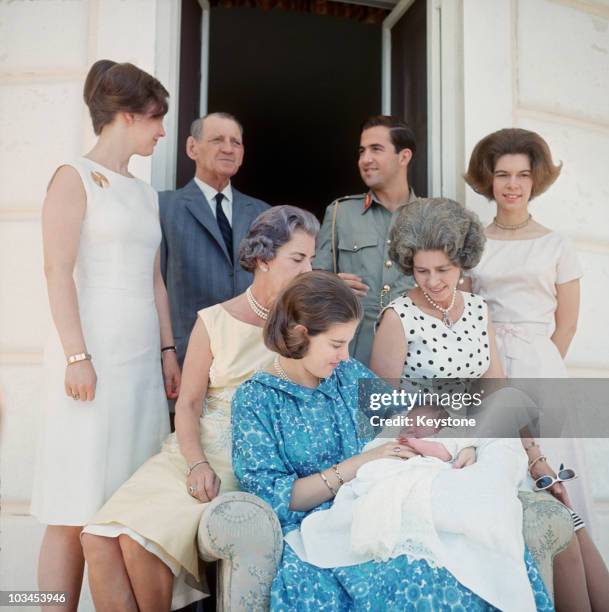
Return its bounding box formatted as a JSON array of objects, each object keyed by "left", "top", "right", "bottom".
[{"left": 464, "top": 128, "right": 562, "bottom": 200}]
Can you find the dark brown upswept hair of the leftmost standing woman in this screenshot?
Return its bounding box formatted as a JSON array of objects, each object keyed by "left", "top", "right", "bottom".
[{"left": 83, "top": 60, "right": 169, "bottom": 135}]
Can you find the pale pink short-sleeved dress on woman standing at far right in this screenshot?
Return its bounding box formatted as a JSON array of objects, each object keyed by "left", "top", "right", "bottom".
[{"left": 469, "top": 232, "right": 594, "bottom": 527}]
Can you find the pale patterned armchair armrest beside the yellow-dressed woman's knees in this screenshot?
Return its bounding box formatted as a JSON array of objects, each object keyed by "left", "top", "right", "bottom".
[{"left": 197, "top": 492, "right": 283, "bottom": 612}]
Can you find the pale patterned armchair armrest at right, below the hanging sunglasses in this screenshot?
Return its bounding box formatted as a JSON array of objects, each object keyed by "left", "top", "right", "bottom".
[{"left": 518, "top": 491, "right": 573, "bottom": 599}]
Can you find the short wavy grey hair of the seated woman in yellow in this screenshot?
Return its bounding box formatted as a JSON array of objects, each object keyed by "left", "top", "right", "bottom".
[{"left": 239, "top": 205, "right": 319, "bottom": 272}]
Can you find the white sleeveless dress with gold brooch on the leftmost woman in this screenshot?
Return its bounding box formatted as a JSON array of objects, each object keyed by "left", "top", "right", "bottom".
[{"left": 31, "top": 158, "right": 169, "bottom": 525}]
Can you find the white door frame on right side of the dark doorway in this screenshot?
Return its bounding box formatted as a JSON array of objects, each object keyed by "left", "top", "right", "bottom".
[{"left": 381, "top": 0, "right": 464, "bottom": 201}]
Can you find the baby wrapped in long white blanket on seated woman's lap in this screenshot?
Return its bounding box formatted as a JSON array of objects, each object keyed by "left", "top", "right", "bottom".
[{"left": 285, "top": 402, "right": 535, "bottom": 610}]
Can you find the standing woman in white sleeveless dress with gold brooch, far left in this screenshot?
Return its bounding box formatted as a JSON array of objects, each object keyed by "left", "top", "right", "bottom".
[{"left": 31, "top": 60, "right": 180, "bottom": 611}]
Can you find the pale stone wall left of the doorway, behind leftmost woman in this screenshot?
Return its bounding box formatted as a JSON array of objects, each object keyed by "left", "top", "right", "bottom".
[{"left": 0, "top": 0, "right": 179, "bottom": 610}]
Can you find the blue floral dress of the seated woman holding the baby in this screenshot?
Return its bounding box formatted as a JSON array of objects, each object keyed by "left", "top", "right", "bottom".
[{"left": 232, "top": 360, "right": 553, "bottom": 612}]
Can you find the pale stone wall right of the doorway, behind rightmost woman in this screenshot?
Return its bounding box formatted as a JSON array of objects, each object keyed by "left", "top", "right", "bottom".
[{"left": 462, "top": 0, "right": 609, "bottom": 560}]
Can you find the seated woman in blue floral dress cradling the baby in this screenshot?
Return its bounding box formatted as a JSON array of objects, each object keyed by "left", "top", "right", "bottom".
[{"left": 232, "top": 272, "right": 553, "bottom": 612}]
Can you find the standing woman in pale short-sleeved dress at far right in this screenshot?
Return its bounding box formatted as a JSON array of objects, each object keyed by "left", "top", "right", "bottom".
[{"left": 465, "top": 128, "right": 609, "bottom": 609}]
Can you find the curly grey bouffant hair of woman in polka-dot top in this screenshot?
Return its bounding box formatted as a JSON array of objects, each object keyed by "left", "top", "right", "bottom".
[{"left": 389, "top": 198, "right": 486, "bottom": 276}]
